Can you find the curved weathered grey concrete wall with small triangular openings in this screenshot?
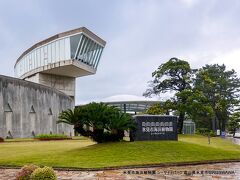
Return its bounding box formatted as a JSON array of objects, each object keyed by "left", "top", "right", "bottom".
[{"left": 0, "top": 75, "right": 74, "bottom": 138}]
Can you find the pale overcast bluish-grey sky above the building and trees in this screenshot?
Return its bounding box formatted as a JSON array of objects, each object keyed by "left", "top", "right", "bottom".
[{"left": 0, "top": 0, "right": 240, "bottom": 104}]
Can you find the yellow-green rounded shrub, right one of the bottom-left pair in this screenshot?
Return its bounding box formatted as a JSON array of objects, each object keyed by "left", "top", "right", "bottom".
[{"left": 31, "top": 166, "right": 57, "bottom": 180}]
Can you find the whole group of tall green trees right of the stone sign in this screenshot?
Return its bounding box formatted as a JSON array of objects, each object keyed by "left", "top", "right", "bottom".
[{"left": 144, "top": 58, "right": 240, "bottom": 133}]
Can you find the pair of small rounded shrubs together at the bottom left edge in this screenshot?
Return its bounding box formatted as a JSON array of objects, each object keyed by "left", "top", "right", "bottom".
[{"left": 16, "top": 164, "right": 57, "bottom": 180}]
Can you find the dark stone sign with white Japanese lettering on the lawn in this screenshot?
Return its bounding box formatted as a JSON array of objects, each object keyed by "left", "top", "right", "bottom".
[{"left": 134, "top": 115, "right": 178, "bottom": 141}]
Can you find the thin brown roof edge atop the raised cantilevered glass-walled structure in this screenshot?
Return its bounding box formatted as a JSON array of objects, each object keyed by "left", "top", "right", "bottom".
[{"left": 14, "top": 27, "right": 106, "bottom": 68}]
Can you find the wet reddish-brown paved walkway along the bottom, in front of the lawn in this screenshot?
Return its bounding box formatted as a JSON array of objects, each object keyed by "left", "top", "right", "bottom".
[{"left": 0, "top": 162, "right": 240, "bottom": 180}]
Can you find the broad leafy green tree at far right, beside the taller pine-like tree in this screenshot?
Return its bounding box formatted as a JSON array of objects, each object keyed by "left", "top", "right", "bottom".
[{"left": 194, "top": 64, "right": 240, "bottom": 131}]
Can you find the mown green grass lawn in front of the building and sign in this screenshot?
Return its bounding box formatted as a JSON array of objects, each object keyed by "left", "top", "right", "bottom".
[{"left": 0, "top": 135, "right": 240, "bottom": 168}]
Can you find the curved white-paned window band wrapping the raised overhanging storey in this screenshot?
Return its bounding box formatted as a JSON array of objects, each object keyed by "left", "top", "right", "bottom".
[{"left": 15, "top": 33, "right": 104, "bottom": 77}]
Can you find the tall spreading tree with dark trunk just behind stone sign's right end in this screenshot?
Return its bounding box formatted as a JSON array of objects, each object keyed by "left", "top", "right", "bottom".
[{"left": 143, "top": 58, "right": 194, "bottom": 133}]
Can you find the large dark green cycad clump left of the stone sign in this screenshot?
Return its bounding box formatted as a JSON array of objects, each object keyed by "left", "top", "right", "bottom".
[{"left": 58, "top": 102, "right": 135, "bottom": 143}]
